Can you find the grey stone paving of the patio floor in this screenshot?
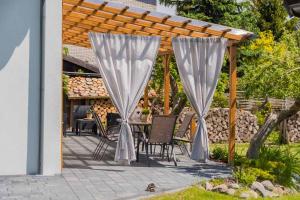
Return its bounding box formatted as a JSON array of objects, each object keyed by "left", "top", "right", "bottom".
[{"left": 0, "top": 136, "right": 230, "bottom": 200}]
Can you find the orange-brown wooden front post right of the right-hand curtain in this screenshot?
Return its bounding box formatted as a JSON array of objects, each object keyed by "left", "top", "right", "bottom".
[{"left": 228, "top": 44, "right": 237, "bottom": 165}]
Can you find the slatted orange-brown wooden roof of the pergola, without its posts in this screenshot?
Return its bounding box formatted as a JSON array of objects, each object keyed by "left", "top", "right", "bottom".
[{"left": 63, "top": 0, "right": 253, "bottom": 54}]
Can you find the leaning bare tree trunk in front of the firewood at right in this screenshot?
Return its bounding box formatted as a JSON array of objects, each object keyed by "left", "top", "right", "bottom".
[{"left": 247, "top": 98, "right": 300, "bottom": 159}]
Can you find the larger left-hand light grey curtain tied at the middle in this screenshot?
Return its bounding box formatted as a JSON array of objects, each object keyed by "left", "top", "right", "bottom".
[{"left": 89, "top": 33, "right": 160, "bottom": 163}]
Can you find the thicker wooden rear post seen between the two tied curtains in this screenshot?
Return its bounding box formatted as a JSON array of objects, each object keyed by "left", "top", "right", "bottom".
[{"left": 163, "top": 54, "right": 171, "bottom": 115}]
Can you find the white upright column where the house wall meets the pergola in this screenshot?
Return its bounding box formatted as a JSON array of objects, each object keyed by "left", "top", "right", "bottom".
[{"left": 41, "top": 0, "right": 62, "bottom": 175}]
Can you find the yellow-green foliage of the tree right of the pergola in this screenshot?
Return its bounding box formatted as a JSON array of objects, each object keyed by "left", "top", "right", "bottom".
[{"left": 239, "top": 31, "right": 300, "bottom": 98}]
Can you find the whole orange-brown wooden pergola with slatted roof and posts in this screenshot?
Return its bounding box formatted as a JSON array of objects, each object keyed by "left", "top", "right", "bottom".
[{"left": 63, "top": 0, "right": 253, "bottom": 163}]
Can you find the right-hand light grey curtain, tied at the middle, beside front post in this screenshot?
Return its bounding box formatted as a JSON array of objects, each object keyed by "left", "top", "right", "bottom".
[{"left": 172, "top": 38, "right": 227, "bottom": 162}]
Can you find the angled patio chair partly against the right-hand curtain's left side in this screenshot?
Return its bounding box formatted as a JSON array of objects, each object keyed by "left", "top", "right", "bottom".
[{"left": 173, "top": 112, "right": 195, "bottom": 157}]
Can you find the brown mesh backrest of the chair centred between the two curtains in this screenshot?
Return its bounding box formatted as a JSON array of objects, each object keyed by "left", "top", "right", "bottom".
[{"left": 149, "top": 115, "right": 177, "bottom": 143}]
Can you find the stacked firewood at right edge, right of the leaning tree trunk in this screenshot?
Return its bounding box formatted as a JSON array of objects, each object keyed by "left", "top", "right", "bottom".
[{"left": 287, "top": 112, "right": 300, "bottom": 142}]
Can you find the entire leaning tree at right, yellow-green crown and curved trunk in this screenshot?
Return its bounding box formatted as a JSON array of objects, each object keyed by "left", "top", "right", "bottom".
[{"left": 240, "top": 31, "right": 300, "bottom": 158}]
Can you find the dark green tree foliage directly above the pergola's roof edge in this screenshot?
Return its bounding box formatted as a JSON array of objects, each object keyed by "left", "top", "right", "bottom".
[{"left": 160, "top": 0, "right": 259, "bottom": 32}]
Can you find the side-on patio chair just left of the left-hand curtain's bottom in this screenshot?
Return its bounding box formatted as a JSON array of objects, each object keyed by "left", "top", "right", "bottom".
[{"left": 92, "top": 110, "right": 120, "bottom": 160}]
